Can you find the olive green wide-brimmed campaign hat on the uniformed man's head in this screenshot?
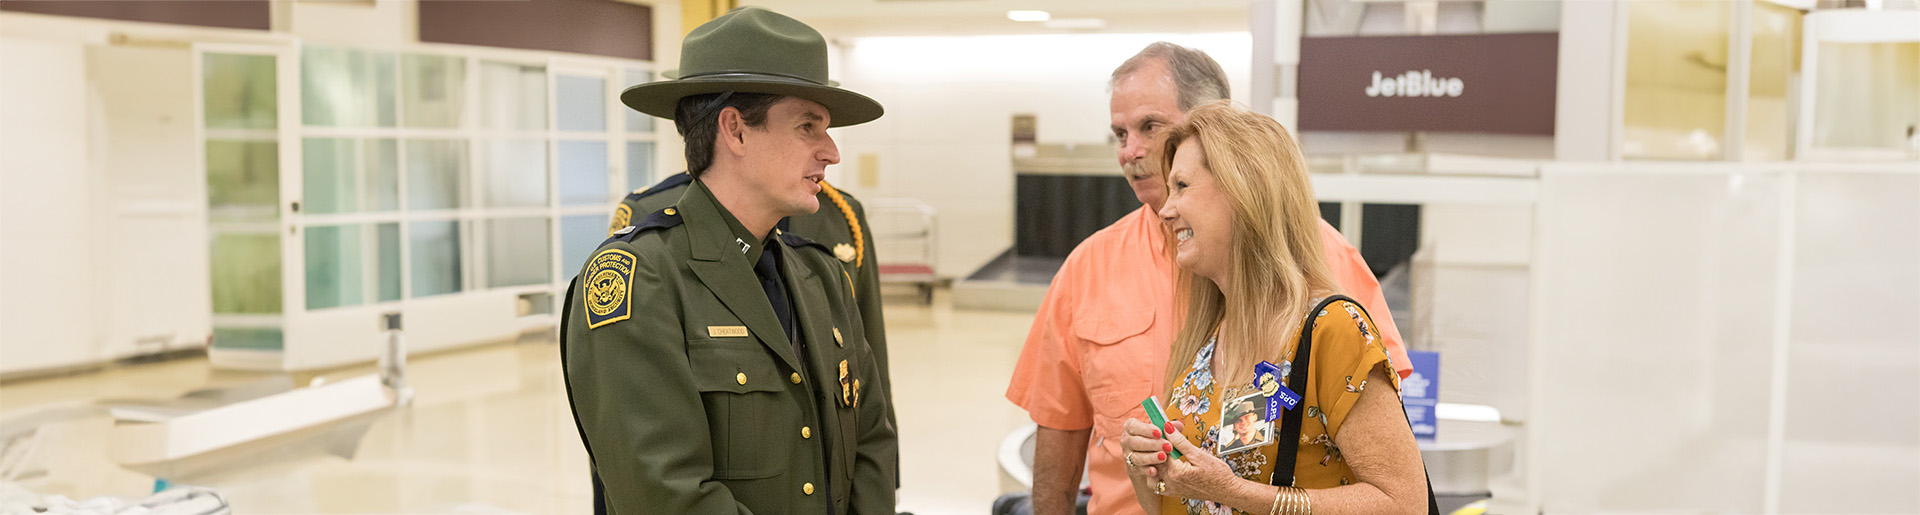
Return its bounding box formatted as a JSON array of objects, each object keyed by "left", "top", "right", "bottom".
[{"left": 620, "top": 8, "right": 885, "bottom": 127}]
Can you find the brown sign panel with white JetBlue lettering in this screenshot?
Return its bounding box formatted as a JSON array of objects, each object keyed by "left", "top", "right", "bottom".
[{"left": 1300, "top": 33, "right": 1559, "bottom": 135}]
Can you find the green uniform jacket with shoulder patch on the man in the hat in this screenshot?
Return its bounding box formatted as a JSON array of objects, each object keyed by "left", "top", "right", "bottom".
[{"left": 561, "top": 183, "right": 899, "bottom": 515}]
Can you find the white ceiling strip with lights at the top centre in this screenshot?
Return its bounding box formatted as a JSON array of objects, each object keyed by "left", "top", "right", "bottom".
[{"left": 739, "top": 0, "right": 1250, "bottom": 38}]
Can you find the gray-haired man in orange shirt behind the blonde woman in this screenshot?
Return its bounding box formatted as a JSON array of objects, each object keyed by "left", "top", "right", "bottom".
[{"left": 1006, "top": 42, "right": 1411, "bottom": 515}]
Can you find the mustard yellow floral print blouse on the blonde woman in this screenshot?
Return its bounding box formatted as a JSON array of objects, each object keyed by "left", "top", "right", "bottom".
[{"left": 1160, "top": 300, "right": 1400, "bottom": 515}]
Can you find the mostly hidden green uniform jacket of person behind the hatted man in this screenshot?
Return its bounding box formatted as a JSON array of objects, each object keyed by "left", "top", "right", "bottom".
[{"left": 607, "top": 173, "right": 899, "bottom": 427}]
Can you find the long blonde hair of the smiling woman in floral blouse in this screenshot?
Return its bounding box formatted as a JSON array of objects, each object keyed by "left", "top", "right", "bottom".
[{"left": 1162, "top": 100, "right": 1340, "bottom": 398}]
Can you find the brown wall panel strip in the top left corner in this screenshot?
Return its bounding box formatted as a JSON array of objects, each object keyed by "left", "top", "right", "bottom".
[{"left": 0, "top": 0, "right": 273, "bottom": 31}]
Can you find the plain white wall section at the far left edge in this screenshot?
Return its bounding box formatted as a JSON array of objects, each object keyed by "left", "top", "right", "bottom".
[{"left": 0, "top": 38, "right": 109, "bottom": 371}]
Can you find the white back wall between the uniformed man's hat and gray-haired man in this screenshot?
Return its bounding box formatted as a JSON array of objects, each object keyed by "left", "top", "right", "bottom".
[{"left": 828, "top": 33, "right": 1252, "bottom": 277}]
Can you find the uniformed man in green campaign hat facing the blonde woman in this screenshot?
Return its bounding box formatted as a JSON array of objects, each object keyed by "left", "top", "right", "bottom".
[{"left": 561, "top": 8, "right": 899, "bottom": 515}]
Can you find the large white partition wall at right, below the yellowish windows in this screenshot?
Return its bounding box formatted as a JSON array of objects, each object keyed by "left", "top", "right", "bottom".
[{"left": 1526, "top": 163, "right": 1920, "bottom": 513}]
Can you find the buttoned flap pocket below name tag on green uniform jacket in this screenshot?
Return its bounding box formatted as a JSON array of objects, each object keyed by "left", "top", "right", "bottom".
[{"left": 687, "top": 340, "right": 799, "bottom": 480}]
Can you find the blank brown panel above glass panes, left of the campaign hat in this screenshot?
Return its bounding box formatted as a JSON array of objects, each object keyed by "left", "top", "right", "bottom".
[{"left": 420, "top": 0, "right": 653, "bottom": 60}]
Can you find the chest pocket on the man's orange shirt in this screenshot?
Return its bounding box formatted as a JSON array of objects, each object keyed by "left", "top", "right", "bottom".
[{"left": 1073, "top": 309, "right": 1171, "bottom": 450}]
